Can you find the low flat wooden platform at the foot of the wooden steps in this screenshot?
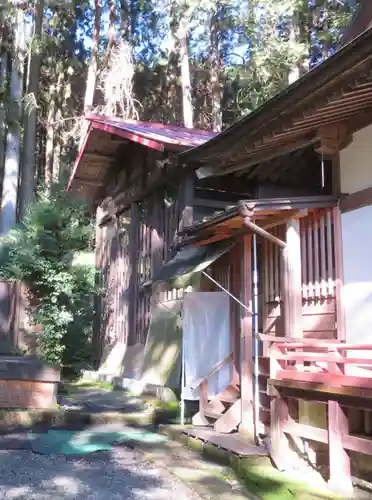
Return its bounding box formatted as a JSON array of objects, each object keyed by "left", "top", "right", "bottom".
[{"left": 184, "top": 427, "right": 268, "bottom": 457}]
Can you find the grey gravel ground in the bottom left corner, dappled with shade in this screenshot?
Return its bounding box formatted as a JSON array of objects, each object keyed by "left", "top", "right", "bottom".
[{"left": 0, "top": 447, "right": 200, "bottom": 500}]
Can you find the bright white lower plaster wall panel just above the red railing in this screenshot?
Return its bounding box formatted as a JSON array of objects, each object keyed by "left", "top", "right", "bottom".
[{"left": 341, "top": 206, "right": 372, "bottom": 358}]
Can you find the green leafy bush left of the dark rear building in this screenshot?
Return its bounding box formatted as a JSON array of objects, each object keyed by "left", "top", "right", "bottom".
[{"left": 0, "top": 186, "right": 95, "bottom": 366}]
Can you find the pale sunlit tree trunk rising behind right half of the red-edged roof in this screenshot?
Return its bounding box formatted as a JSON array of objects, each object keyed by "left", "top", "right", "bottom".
[{"left": 178, "top": 6, "right": 194, "bottom": 128}]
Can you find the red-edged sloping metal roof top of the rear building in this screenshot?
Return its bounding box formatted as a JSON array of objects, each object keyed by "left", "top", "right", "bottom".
[{"left": 86, "top": 115, "right": 217, "bottom": 151}]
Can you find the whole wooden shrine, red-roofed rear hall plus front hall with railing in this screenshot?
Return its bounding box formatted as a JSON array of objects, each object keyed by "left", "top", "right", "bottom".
[{"left": 69, "top": 9, "right": 372, "bottom": 493}]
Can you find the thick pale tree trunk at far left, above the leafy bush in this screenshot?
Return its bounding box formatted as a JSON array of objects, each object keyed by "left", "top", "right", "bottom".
[{"left": 0, "top": 8, "right": 25, "bottom": 234}]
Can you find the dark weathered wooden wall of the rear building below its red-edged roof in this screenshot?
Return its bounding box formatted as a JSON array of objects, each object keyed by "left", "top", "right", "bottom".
[{"left": 93, "top": 166, "right": 193, "bottom": 364}]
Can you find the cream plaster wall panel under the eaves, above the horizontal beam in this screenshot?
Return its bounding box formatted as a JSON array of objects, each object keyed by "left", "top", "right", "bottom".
[{"left": 340, "top": 125, "right": 372, "bottom": 194}]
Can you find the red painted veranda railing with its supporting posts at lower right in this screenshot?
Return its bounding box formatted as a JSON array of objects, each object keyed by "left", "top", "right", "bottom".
[{"left": 261, "top": 335, "right": 372, "bottom": 494}]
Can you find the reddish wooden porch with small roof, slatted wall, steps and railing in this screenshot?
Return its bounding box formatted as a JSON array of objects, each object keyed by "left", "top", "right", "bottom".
[{"left": 176, "top": 196, "right": 372, "bottom": 489}]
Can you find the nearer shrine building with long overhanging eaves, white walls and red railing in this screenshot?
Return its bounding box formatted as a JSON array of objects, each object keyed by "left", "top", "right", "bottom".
[{"left": 171, "top": 20, "right": 372, "bottom": 494}]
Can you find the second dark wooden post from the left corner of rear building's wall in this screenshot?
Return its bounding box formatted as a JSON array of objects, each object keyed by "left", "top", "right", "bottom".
[{"left": 128, "top": 203, "right": 140, "bottom": 345}]
